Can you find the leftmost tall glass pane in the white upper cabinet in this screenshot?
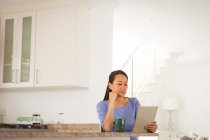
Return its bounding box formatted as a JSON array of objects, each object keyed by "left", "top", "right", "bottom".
[{"left": 3, "top": 19, "right": 14, "bottom": 83}]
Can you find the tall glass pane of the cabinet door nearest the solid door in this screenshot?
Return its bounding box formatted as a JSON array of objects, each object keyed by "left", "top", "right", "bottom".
[{"left": 20, "top": 17, "right": 32, "bottom": 82}]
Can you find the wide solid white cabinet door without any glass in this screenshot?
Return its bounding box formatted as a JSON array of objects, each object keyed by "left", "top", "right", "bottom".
[{"left": 35, "top": 7, "right": 76, "bottom": 86}]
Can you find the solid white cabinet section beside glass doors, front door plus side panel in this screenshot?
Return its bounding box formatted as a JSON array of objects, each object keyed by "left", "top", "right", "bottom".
[{"left": 35, "top": 6, "right": 89, "bottom": 87}]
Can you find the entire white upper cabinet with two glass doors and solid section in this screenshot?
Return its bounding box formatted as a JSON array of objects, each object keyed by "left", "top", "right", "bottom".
[{"left": 0, "top": 5, "right": 89, "bottom": 88}]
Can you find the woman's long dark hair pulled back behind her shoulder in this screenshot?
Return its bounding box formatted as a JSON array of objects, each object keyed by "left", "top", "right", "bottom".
[{"left": 104, "top": 70, "right": 128, "bottom": 101}]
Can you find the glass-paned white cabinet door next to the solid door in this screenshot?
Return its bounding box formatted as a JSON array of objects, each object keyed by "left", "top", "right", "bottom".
[{"left": 16, "top": 12, "right": 35, "bottom": 87}]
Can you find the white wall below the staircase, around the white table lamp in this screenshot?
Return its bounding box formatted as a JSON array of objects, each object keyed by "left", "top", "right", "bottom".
[{"left": 153, "top": 53, "right": 210, "bottom": 136}]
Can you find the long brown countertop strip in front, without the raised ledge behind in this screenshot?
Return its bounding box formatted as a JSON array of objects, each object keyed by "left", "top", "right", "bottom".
[{"left": 0, "top": 129, "right": 158, "bottom": 138}]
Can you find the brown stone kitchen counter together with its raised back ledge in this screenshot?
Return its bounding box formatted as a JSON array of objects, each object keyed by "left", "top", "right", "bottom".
[{"left": 0, "top": 124, "right": 158, "bottom": 139}]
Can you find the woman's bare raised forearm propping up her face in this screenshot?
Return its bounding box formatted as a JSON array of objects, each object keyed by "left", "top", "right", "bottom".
[{"left": 104, "top": 101, "right": 115, "bottom": 132}]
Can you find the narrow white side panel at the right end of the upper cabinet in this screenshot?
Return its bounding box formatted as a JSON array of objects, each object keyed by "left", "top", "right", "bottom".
[{"left": 75, "top": 6, "right": 90, "bottom": 87}]
